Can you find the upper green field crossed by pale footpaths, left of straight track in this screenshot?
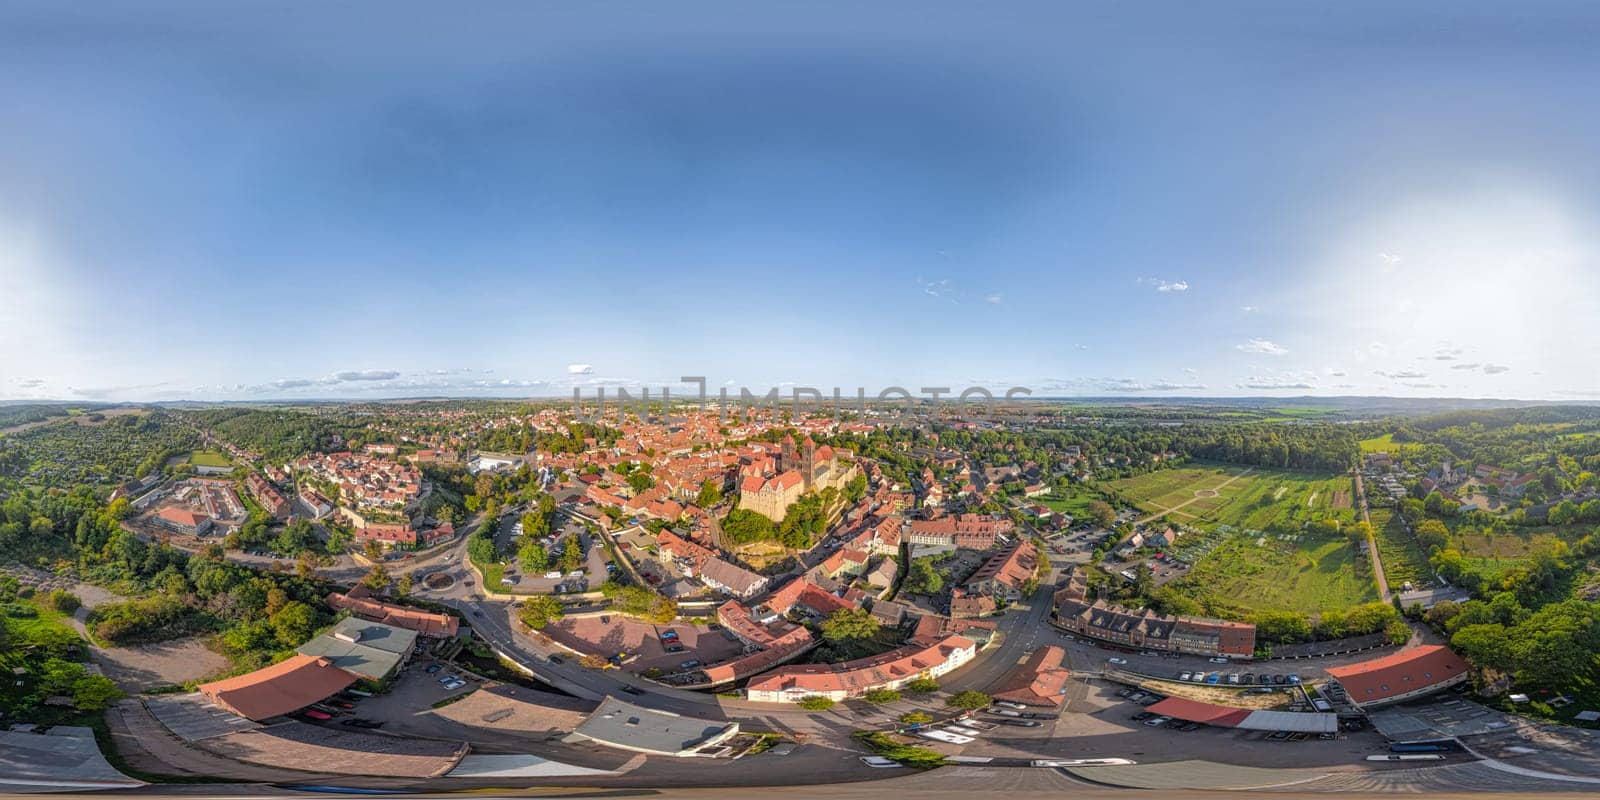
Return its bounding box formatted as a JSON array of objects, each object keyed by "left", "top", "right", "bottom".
[{"left": 1109, "top": 466, "right": 1355, "bottom": 531}]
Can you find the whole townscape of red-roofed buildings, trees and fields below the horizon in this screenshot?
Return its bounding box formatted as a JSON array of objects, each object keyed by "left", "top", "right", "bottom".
[{"left": 9, "top": 394, "right": 1600, "bottom": 789}]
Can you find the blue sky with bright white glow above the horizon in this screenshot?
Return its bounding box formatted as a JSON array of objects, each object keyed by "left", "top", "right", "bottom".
[{"left": 0, "top": 2, "right": 1600, "bottom": 400}]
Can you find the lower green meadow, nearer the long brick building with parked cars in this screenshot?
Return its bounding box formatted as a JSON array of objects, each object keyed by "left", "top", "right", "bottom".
[{"left": 1173, "top": 534, "right": 1378, "bottom": 613}]
